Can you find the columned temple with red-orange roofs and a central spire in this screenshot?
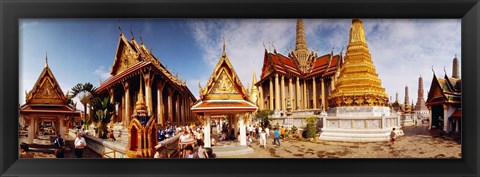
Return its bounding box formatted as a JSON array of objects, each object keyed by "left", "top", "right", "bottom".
[{"left": 252, "top": 19, "right": 343, "bottom": 117}]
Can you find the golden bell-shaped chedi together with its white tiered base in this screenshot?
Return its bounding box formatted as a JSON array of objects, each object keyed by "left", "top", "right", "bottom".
[{"left": 320, "top": 19, "right": 403, "bottom": 142}]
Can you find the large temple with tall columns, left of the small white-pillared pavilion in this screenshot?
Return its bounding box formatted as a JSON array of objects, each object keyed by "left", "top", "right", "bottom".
[{"left": 95, "top": 30, "right": 196, "bottom": 129}]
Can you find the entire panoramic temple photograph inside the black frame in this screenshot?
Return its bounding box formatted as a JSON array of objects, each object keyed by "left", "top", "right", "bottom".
[{"left": 18, "top": 18, "right": 462, "bottom": 159}]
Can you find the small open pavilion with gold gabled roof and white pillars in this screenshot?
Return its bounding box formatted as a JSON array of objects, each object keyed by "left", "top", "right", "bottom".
[{"left": 191, "top": 43, "right": 257, "bottom": 147}]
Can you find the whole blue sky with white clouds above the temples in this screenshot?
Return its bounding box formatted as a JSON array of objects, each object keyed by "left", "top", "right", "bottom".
[{"left": 19, "top": 19, "right": 461, "bottom": 109}]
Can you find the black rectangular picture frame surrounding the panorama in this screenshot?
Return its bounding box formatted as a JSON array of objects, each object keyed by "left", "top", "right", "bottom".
[{"left": 0, "top": 0, "right": 480, "bottom": 176}]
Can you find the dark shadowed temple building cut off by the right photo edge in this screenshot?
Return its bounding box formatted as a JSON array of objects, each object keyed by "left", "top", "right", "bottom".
[{"left": 426, "top": 56, "right": 462, "bottom": 133}]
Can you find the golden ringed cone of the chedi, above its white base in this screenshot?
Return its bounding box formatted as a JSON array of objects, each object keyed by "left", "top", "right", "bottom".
[{"left": 329, "top": 19, "right": 388, "bottom": 107}]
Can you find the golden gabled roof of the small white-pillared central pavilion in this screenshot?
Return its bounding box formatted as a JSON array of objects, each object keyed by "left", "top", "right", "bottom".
[{"left": 191, "top": 44, "right": 257, "bottom": 113}]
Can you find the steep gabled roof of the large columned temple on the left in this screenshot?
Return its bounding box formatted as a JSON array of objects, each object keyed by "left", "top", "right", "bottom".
[{"left": 96, "top": 33, "right": 194, "bottom": 97}]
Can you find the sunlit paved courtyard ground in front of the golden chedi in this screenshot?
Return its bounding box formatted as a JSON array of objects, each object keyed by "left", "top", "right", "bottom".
[{"left": 222, "top": 126, "right": 461, "bottom": 158}]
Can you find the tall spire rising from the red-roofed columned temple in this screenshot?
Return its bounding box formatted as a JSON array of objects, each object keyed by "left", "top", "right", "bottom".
[{"left": 294, "top": 19, "right": 309, "bottom": 72}]
